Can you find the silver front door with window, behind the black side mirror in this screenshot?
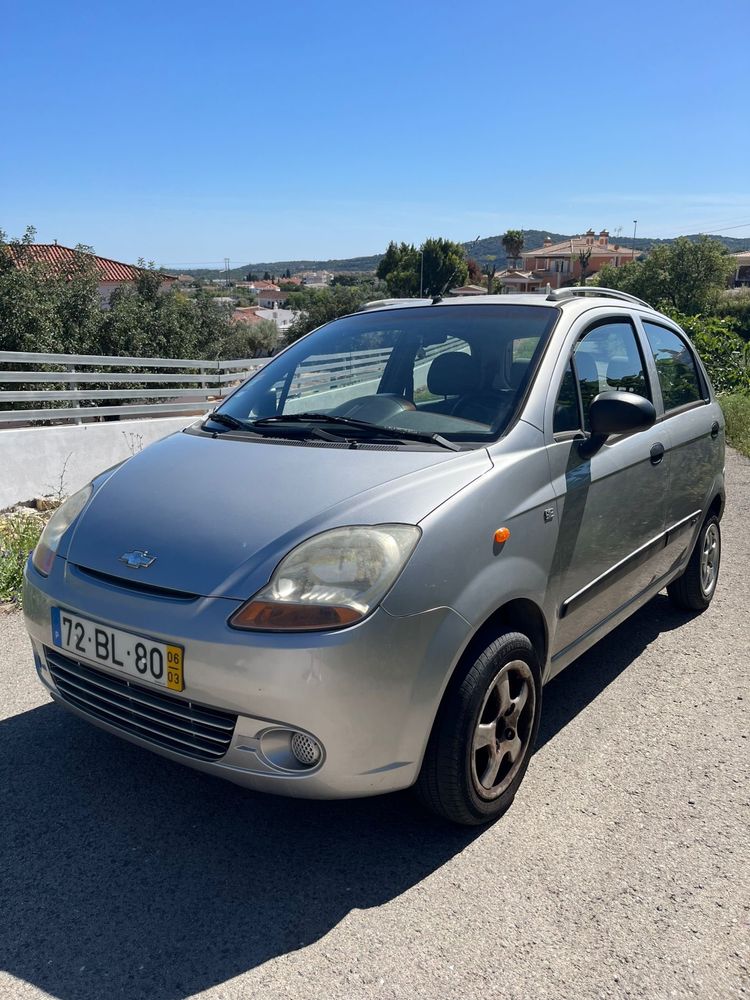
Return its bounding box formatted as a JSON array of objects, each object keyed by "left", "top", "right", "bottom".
[{"left": 545, "top": 311, "right": 669, "bottom": 663}]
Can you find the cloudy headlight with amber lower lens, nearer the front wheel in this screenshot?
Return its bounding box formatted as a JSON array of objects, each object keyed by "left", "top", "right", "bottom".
[{"left": 229, "top": 524, "right": 421, "bottom": 632}]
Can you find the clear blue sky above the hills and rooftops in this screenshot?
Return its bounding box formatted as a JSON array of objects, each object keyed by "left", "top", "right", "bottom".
[{"left": 0, "top": 0, "right": 750, "bottom": 268}]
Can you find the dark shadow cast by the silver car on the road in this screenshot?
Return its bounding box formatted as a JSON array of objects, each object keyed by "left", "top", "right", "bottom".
[{"left": 0, "top": 598, "right": 696, "bottom": 1000}]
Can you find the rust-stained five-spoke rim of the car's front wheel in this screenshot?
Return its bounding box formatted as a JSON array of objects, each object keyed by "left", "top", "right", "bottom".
[{"left": 471, "top": 660, "right": 536, "bottom": 800}]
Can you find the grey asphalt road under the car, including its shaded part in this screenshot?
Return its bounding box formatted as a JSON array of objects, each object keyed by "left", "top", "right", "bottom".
[{"left": 0, "top": 453, "right": 750, "bottom": 1000}]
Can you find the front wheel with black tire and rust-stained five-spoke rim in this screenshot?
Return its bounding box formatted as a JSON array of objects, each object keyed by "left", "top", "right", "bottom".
[{"left": 416, "top": 632, "right": 542, "bottom": 826}]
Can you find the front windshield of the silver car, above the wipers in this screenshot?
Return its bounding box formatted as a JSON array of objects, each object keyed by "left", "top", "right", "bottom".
[{"left": 214, "top": 303, "right": 558, "bottom": 443}]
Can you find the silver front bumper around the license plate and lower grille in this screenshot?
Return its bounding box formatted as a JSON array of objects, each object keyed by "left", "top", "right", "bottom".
[{"left": 24, "top": 558, "right": 470, "bottom": 798}]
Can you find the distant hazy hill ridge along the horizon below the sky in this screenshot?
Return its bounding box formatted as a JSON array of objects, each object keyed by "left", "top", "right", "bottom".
[{"left": 183, "top": 229, "right": 750, "bottom": 281}]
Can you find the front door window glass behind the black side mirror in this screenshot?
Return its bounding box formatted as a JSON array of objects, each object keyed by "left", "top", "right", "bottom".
[{"left": 573, "top": 319, "right": 651, "bottom": 431}]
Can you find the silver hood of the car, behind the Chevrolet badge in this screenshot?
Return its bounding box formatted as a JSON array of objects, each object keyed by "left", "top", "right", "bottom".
[{"left": 66, "top": 433, "right": 491, "bottom": 600}]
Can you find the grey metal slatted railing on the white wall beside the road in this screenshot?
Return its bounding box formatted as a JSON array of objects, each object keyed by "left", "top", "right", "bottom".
[{"left": 0, "top": 351, "right": 269, "bottom": 428}]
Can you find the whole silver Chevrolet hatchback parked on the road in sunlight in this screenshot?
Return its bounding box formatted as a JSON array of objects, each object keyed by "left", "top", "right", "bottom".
[{"left": 24, "top": 289, "right": 724, "bottom": 824}]
